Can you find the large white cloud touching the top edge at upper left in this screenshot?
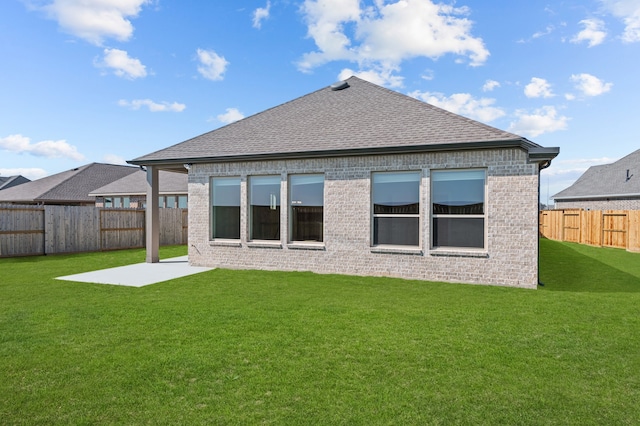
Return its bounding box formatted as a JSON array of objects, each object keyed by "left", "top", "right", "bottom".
[{"left": 34, "top": 0, "right": 152, "bottom": 45}]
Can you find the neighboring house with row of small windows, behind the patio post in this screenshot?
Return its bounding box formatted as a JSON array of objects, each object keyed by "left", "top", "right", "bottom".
[{"left": 89, "top": 169, "right": 187, "bottom": 209}]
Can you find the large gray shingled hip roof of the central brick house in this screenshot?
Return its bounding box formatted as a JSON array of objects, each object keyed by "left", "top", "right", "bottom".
[{"left": 129, "top": 77, "right": 558, "bottom": 167}]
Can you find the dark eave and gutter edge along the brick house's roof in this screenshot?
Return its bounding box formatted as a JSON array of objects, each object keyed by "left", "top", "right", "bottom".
[{"left": 127, "top": 138, "right": 560, "bottom": 167}]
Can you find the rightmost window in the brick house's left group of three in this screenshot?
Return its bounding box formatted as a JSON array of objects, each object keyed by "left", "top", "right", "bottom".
[{"left": 289, "top": 175, "right": 324, "bottom": 241}]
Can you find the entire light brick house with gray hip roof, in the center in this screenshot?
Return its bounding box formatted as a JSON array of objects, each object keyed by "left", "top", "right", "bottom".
[{"left": 129, "top": 77, "right": 559, "bottom": 288}]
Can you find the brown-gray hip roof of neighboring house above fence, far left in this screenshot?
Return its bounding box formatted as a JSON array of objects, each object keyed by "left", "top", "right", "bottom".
[{"left": 0, "top": 163, "right": 139, "bottom": 204}]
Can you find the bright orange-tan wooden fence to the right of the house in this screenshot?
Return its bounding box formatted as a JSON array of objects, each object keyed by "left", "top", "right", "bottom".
[{"left": 540, "top": 209, "right": 640, "bottom": 252}]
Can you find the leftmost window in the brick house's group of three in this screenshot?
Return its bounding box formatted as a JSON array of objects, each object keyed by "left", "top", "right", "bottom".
[{"left": 211, "top": 177, "right": 240, "bottom": 239}]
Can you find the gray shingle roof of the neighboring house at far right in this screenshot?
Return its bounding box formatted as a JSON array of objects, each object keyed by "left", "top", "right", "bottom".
[{"left": 551, "top": 149, "right": 640, "bottom": 201}]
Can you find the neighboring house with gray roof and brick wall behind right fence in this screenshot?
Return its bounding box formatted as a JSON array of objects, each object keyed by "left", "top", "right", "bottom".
[{"left": 552, "top": 149, "right": 640, "bottom": 210}]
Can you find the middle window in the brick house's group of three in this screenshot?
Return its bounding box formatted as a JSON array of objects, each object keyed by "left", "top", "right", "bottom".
[{"left": 249, "top": 176, "right": 280, "bottom": 240}]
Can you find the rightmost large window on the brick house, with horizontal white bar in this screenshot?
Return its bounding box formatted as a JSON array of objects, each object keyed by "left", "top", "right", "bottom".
[{"left": 431, "top": 170, "right": 486, "bottom": 248}]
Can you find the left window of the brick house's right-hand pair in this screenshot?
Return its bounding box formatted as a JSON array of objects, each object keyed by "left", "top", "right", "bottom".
[{"left": 372, "top": 172, "right": 420, "bottom": 246}]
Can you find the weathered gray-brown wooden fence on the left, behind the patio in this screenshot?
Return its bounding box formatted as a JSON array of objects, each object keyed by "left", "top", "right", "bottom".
[{"left": 0, "top": 205, "right": 188, "bottom": 257}]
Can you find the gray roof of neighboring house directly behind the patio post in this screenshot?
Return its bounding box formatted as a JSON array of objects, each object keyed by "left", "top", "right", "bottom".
[{"left": 89, "top": 169, "right": 188, "bottom": 197}]
